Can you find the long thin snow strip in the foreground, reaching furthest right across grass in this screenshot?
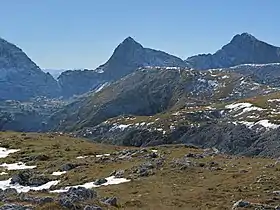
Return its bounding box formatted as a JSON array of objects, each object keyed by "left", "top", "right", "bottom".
[{"left": 50, "top": 176, "right": 130, "bottom": 193}]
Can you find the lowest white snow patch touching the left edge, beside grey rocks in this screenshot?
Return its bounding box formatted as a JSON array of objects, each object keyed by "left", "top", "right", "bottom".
[{"left": 0, "top": 178, "right": 59, "bottom": 193}]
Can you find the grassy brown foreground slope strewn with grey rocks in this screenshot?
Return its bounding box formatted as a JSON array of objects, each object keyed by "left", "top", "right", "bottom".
[{"left": 0, "top": 133, "right": 280, "bottom": 210}]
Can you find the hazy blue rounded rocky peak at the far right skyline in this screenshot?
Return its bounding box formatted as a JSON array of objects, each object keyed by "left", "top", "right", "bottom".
[{"left": 186, "top": 33, "right": 280, "bottom": 69}]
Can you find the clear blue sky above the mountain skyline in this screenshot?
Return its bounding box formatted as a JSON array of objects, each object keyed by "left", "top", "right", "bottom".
[{"left": 0, "top": 0, "right": 280, "bottom": 69}]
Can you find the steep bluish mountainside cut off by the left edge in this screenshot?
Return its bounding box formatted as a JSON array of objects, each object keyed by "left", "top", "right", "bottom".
[{"left": 0, "top": 39, "right": 59, "bottom": 100}]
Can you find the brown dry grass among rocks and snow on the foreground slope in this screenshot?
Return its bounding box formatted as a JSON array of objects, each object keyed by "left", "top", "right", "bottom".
[{"left": 0, "top": 133, "right": 280, "bottom": 210}]
